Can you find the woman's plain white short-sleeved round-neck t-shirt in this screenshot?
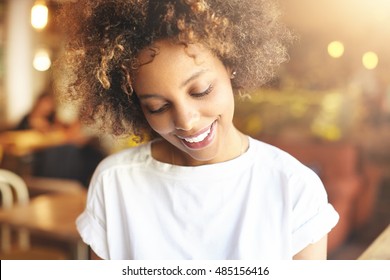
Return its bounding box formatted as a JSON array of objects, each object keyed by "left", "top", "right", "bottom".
[{"left": 77, "top": 138, "right": 339, "bottom": 260}]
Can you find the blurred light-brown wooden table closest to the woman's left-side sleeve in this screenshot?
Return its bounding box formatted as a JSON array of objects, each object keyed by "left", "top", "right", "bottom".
[{"left": 0, "top": 191, "right": 88, "bottom": 259}]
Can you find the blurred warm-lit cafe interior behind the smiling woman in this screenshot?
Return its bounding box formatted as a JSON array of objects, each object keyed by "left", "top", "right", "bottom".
[{"left": 0, "top": 0, "right": 390, "bottom": 260}]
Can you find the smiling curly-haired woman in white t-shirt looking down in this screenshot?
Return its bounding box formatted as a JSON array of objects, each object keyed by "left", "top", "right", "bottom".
[{"left": 56, "top": 0, "right": 338, "bottom": 259}]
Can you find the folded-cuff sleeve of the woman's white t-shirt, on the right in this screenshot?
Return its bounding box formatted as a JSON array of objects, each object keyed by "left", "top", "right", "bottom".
[{"left": 291, "top": 166, "right": 339, "bottom": 255}]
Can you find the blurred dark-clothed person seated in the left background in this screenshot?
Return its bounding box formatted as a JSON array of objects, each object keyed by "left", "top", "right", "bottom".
[{"left": 15, "top": 90, "right": 105, "bottom": 187}]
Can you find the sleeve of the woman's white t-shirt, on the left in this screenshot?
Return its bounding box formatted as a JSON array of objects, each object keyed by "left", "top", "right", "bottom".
[{"left": 76, "top": 174, "right": 109, "bottom": 259}]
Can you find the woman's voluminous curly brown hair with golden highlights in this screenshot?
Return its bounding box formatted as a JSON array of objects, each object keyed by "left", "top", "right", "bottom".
[{"left": 57, "top": 0, "right": 291, "bottom": 137}]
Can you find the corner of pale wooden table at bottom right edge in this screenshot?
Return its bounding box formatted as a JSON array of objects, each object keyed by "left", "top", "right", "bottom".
[{"left": 358, "top": 225, "right": 390, "bottom": 260}]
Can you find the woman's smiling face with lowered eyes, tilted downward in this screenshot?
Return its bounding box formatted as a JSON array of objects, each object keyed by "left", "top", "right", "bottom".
[{"left": 134, "top": 41, "right": 240, "bottom": 165}]
